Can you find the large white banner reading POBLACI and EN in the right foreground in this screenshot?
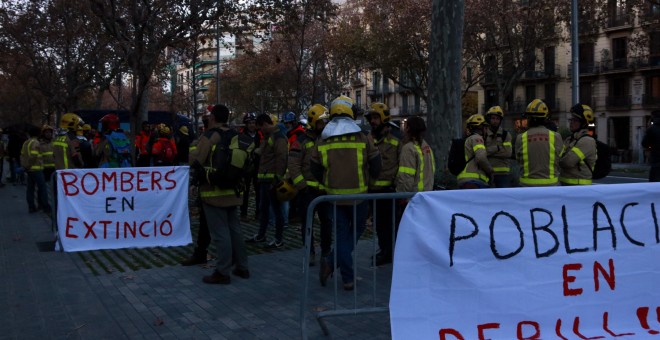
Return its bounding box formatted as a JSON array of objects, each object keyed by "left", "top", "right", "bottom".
[{"left": 390, "top": 183, "right": 660, "bottom": 340}]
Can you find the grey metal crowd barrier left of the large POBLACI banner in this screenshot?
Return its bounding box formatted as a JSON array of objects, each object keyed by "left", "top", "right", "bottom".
[{"left": 300, "top": 192, "right": 415, "bottom": 340}]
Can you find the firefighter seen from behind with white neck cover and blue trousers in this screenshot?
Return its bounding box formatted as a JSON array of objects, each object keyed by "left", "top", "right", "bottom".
[{"left": 311, "top": 96, "right": 381, "bottom": 290}]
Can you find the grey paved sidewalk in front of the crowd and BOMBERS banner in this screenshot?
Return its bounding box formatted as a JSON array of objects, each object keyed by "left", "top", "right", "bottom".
[{"left": 0, "top": 184, "right": 391, "bottom": 339}]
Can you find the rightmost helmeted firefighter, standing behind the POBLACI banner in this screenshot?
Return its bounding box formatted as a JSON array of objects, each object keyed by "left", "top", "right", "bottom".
[{"left": 559, "top": 103, "right": 598, "bottom": 185}]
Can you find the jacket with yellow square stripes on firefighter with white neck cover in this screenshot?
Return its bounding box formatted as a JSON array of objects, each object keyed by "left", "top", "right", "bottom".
[{"left": 311, "top": 131, "right": 381, "bottom": 204}]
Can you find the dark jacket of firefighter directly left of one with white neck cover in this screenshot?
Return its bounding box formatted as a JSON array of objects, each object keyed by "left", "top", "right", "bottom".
[{"left": 287, "top": 130, "right": 323, "bottom": 192}]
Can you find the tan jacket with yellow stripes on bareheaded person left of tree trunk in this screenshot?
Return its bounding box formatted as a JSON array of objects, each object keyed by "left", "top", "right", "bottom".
[{"left": 396, "top": 140, "right": 435, "bottom": 192}]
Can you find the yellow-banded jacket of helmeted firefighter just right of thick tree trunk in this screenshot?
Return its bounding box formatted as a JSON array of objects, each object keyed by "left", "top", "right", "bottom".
[{"left": 456, "top": 133, "right": 493, "bottom": 186}]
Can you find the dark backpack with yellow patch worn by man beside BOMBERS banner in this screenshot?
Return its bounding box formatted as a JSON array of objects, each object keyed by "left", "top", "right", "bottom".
[{"left": 206, "top": 129, "right": 254, "bottom": 196}]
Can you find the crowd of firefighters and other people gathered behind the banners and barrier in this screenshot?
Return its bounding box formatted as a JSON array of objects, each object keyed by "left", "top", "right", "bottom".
[{"left": 0, "top": 96, "right": 660, "bottom": 290}]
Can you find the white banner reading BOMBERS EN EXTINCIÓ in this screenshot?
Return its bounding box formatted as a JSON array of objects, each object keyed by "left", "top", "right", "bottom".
[{"left": 56, "top": 166, "right": 192, "bottom": 251}]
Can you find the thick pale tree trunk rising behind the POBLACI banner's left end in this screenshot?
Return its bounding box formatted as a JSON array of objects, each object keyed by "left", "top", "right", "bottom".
[{"left": 426, "top": 0, "right": 465, "bottom": 173}]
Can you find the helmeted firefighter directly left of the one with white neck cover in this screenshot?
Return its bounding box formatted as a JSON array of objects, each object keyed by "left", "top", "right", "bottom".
[{"left": 287, "top": 104, "right": 332, "bottom": 266}]
